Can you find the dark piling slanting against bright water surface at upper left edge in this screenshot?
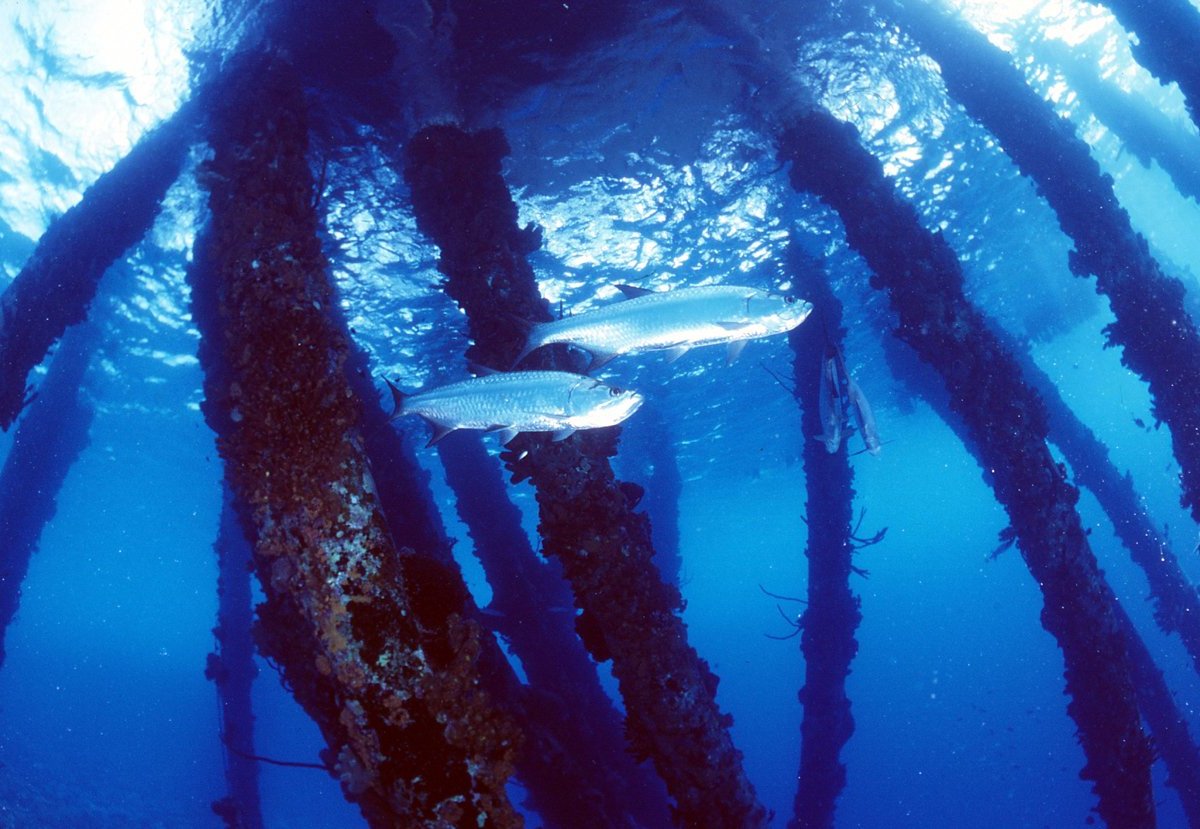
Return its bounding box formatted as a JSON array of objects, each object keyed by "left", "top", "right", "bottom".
[{"left": 0, "top": 104, "right": 194, "bottom": 429}]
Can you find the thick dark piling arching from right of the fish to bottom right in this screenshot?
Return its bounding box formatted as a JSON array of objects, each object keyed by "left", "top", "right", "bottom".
[{"left": 778, "top": 110, "right": 1154, "bottom": 829}]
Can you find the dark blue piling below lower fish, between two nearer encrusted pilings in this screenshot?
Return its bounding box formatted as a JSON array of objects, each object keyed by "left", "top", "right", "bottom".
[{"left": 438, "top": 432, "right": 670, "bottom": 829}]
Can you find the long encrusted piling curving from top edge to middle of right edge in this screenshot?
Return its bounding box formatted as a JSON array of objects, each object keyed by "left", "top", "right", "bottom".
[{"left": 880, "top": 1, "right": 1200, "bottom": 521}]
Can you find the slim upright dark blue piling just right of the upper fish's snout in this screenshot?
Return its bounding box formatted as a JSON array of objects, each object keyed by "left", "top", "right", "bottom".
[{"left": 788, "top": 242, "right": 863, "bottom": 829}]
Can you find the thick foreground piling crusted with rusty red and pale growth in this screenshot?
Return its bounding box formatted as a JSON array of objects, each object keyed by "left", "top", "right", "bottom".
[{"left": 191, "top": 58, "right": 520, "bottom": 827}]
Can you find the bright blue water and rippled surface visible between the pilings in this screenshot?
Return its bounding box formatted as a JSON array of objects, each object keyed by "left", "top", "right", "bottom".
[{"left": 0, "top": 0, "right": 1200, "bottom": 829}]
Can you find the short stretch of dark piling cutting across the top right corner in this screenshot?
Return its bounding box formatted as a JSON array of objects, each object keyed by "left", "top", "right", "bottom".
[{"left": 1092, "top": 0, "right": 1200, "bottom": 126}]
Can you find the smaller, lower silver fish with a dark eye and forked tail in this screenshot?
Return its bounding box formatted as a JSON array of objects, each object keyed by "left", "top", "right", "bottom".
[{"left": 388, "top": 371, "right": 642, "bottom": 446}]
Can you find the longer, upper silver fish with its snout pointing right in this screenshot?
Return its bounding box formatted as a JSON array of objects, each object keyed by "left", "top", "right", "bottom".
[{"left": 517, "top": 286, "right": 812, "bottom": 368}]
